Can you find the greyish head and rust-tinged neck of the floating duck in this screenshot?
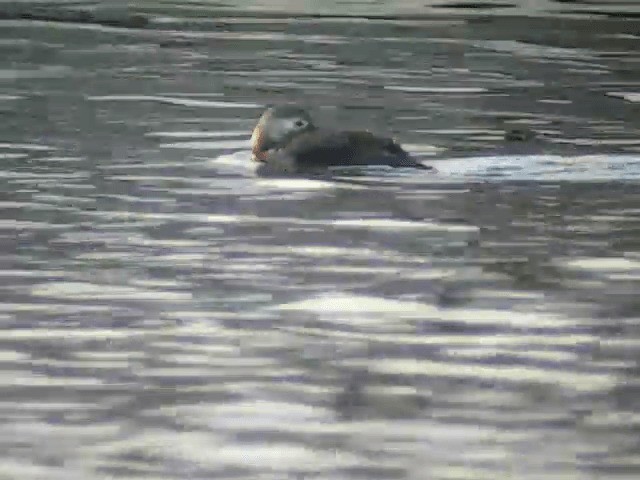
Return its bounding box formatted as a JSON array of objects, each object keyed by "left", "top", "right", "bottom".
[{"left": 251, "top": 105, "right": 315, "bottom": 162}]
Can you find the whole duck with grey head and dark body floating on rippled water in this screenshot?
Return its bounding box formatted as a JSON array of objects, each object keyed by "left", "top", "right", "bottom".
[{"left": 251, "top": 105, "right": 431, "bottom": 173}]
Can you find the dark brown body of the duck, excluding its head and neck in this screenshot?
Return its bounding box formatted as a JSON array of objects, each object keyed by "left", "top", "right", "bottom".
[{"left": 278, "top": 130, "right": 431, "bottom": 171}]
